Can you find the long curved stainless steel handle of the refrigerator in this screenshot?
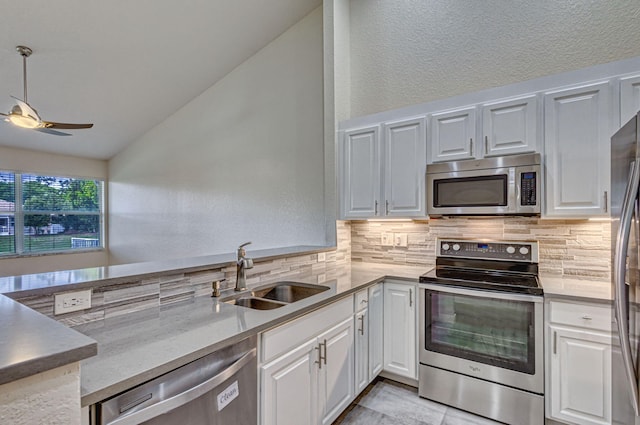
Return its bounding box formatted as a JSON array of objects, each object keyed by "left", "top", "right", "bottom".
[{"left": 613, "top": 161, "right": 640, "bottom": 416}]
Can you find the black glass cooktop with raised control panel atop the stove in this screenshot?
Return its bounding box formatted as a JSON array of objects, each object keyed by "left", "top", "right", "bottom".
[{"left": 420, "top": 239, "right": 543, "bottom": 295}]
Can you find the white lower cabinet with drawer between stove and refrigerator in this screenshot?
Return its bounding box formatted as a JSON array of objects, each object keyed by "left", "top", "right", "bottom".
[{"left": 546, "top": 301, "right": 612, "bottom": 425}]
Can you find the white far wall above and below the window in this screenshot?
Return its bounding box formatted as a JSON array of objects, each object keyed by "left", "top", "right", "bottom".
[{"left": 0, "top": 147, "right": 109, "bottom": 276}]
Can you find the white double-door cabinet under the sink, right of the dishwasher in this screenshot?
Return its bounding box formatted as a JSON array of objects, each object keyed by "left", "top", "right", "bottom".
[{"left": 259, "top": 297, "right": 355, "bottom": 425}]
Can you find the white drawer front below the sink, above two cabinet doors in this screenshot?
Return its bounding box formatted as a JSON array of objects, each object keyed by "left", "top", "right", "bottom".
[{"left": 259, "top": 295, "right": 353, "bottom": 363}]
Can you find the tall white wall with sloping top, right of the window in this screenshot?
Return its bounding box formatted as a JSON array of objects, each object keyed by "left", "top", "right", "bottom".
[{"left": 109, "top": 8, "right": 324, "bottom": 264}]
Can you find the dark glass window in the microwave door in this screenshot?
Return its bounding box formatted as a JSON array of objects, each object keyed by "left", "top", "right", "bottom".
[{"left": 433, "top": 174, "right": 507, "bottom": 208}]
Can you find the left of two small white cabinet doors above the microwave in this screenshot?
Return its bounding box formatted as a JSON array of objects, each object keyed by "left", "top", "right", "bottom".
[{"left": 429, "top": 107, "right": 477, "bottom": 162}]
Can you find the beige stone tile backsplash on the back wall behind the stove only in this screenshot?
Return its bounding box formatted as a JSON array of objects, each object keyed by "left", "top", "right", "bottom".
[{"left": 351, "top": 217, "right": 611, "bottom": 281}]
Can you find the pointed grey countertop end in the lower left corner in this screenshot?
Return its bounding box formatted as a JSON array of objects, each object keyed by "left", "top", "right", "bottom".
[{"left": 0, "top": 295, "right": 97, "bottom": 384}]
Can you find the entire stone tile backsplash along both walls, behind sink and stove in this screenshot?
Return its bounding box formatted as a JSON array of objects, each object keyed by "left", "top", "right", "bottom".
[{"left": 16, "top": 218, "right": 611, "bottom": 326}]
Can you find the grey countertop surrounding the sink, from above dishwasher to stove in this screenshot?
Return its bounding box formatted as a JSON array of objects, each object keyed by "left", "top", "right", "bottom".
[{"left": 74, "top": 263, "right": 427, "bottom": 406}]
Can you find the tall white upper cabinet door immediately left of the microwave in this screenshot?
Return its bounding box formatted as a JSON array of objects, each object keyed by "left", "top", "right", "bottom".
[{"left": 383, "top": 118, "right": 427, "bottom": 217}]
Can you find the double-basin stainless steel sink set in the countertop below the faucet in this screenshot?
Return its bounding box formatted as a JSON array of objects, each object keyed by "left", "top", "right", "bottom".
[{"left": 221, "top": 281, "right": 329, "bottom": 310}]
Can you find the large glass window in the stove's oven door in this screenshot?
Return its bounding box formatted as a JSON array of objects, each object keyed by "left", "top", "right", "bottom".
[{"left": 425, "top": 290, "right": 535, "bottom": 375}]
